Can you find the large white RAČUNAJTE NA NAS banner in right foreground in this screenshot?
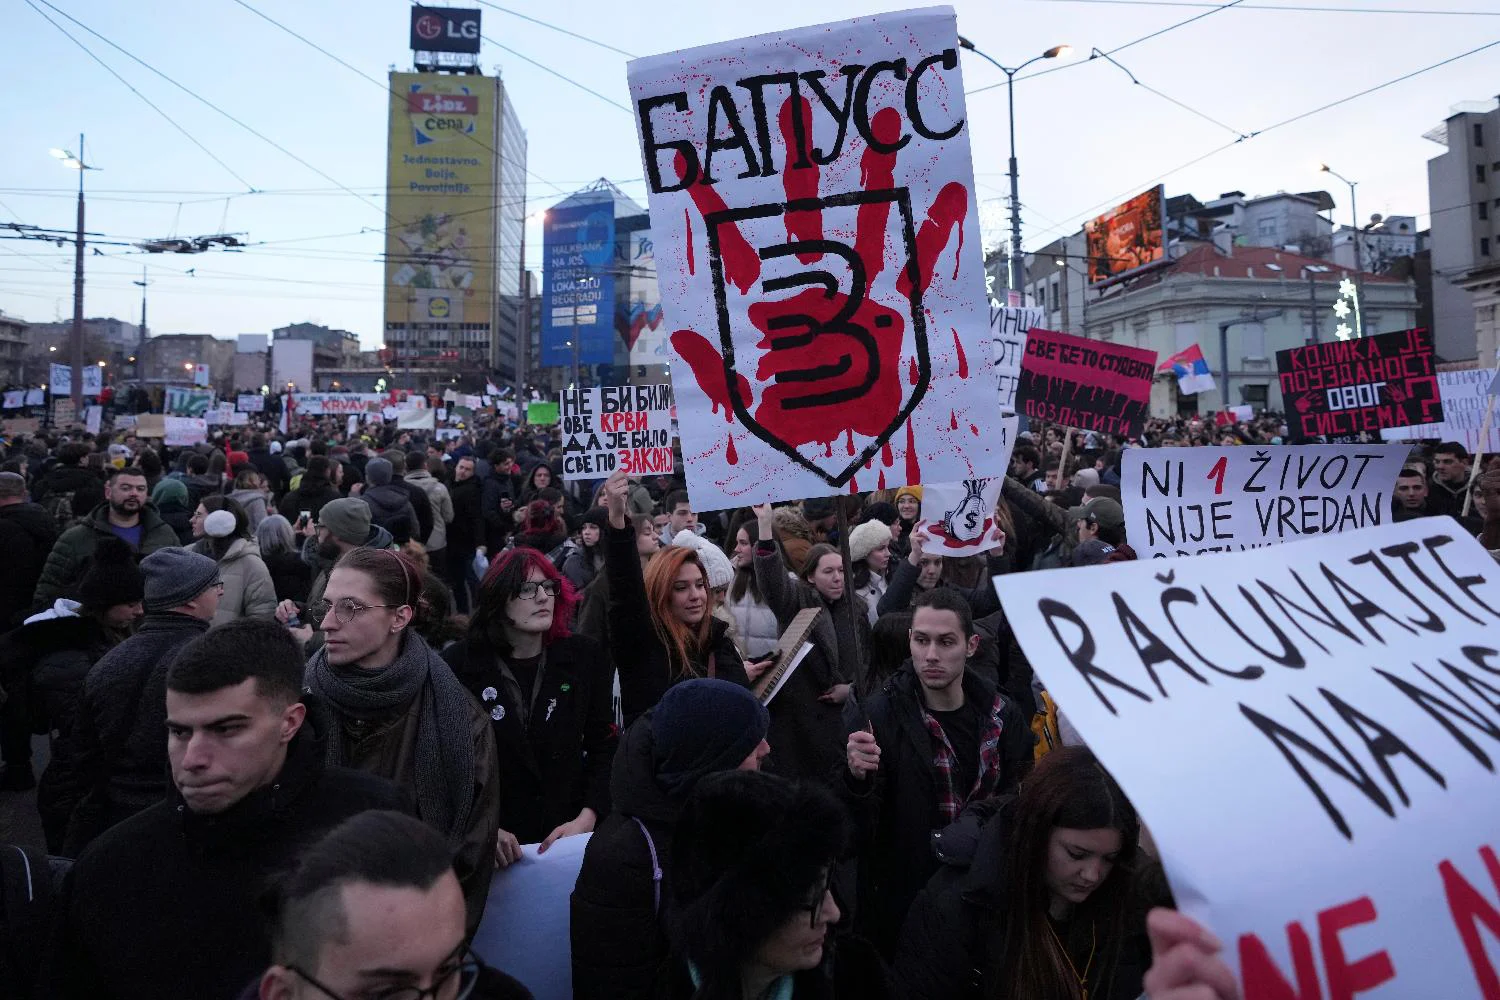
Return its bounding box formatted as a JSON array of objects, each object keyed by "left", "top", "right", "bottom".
[{"left": 995, "top": 517, "right": 1500, "bottom": 1000}]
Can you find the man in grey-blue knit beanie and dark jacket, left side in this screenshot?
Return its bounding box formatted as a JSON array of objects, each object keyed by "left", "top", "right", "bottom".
[{"left": 63, "top": 547, "right": 224, "bottom": 858}]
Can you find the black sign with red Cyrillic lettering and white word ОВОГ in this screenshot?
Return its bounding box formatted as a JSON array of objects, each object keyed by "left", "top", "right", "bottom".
[{"left": 1277, "top": 330, "right": 1443, "bottom": 441}]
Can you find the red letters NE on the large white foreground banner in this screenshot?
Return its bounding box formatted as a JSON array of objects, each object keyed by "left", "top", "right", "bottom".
[{"left": 1239, "top": 897, "right": 1398, "bottom": 1000}]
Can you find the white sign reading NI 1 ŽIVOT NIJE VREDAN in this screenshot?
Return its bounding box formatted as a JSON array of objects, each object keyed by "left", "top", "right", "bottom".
[{"left": 1121, "top": 444, "right": 1407, "bottom": 558}]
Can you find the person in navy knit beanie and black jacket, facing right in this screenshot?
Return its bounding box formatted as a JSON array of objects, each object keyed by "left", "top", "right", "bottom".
[{"left": 570, "top": 678, "right": 771, "bottom": 1000}]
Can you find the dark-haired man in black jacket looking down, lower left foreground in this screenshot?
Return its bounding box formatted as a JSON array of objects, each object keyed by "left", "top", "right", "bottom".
[{"left": 44, "top": 619, "right": 408, "bottom": 1000}]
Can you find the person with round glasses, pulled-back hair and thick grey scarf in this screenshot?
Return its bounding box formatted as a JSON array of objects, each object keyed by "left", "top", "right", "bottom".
[{"left": 306, "top": 549, "right": 500, "bottom": 930}]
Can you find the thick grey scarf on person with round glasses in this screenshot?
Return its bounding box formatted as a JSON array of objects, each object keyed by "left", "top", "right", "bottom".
[{"left": 306, "top": 628, "right": 474, "bottom": 846}]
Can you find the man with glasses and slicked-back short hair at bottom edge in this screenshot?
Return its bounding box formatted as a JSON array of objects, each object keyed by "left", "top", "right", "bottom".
[{"left": 258, "top": 811, "right": 531, "bottom": 1000}]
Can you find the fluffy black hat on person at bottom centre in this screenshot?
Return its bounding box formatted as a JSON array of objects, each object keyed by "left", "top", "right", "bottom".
[{"left": 671, "top": 771, "right": 849, "bottom": 988}]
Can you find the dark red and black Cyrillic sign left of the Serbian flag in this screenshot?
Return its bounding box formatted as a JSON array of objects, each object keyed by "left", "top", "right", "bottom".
[{"left": 1016, "top": 328, "right": 1157, "bottom": 436}]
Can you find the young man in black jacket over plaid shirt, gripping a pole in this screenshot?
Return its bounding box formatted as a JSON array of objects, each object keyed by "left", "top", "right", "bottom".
[{"left": 842, "top": 588, "right": 1034, "bottom": 958}]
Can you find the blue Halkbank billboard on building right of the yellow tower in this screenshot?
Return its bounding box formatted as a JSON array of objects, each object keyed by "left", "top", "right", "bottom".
[{"left": 542, "top": 193, "right": 615, "bottom": 367}]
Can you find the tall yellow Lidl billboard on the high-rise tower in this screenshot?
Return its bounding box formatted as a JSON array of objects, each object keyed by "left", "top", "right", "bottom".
[{"left": 386, "top": 73, "right": 497, "bottom": 338}]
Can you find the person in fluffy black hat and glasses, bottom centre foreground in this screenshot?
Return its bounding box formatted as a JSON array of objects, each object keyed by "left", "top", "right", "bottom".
[{"left": 654, "top": 771, "right": 891, "bottom": 1000}]
